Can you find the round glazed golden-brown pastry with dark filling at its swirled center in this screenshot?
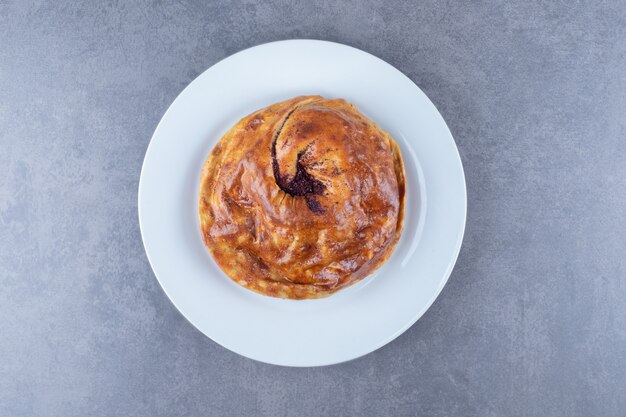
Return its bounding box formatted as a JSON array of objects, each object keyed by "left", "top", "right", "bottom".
[{"left": 199, "top": 96, "right": 405, "bottom": 299}]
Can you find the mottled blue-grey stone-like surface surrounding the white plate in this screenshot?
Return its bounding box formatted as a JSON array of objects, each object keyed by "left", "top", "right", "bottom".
[{"left": 0, "top": 0, "right": 626, "bottom": 417}]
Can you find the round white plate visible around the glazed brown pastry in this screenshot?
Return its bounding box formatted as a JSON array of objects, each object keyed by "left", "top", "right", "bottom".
[{"left": 139, "top": 40, "right": 466, "bottom": 366}]
